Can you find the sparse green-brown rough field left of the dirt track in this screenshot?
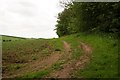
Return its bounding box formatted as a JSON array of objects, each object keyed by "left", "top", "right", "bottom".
[{"left": 2, "top": 39, "right": 54, "bottom": 77}]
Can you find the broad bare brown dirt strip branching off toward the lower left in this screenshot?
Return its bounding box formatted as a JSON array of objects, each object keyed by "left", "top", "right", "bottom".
[{"left": 5, "top": 52, "right": 61, "bottom": 78}]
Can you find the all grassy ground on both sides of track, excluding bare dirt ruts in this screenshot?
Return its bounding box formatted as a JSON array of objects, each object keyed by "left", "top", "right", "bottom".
[{"left": 2, "top": 33, "right": 118, "bottom": 78}]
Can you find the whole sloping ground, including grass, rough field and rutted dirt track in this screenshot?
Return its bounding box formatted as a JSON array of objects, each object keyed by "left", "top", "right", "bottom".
[{"left": 3, "top": 33, "right": 118, "bottom": 78}]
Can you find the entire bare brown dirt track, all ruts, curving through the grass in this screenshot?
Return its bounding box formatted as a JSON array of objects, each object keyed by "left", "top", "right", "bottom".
[{"left": 5, "top": 41, "right": 92, "bottom": 78}]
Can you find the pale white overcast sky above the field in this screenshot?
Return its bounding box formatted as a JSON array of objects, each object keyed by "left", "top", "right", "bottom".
[{"left": 0, "top": 0, "right": 62, "bottom": 38}]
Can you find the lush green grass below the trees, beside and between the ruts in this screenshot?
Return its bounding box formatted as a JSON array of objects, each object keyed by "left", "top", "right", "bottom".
[{"left": 21, "top": 33, "right": 118, "bottom": 78}]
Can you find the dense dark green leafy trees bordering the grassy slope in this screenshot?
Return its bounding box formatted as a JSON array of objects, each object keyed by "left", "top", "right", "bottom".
[{"left": 56, "top": 2, "right": 120, "bottom": 37}]
